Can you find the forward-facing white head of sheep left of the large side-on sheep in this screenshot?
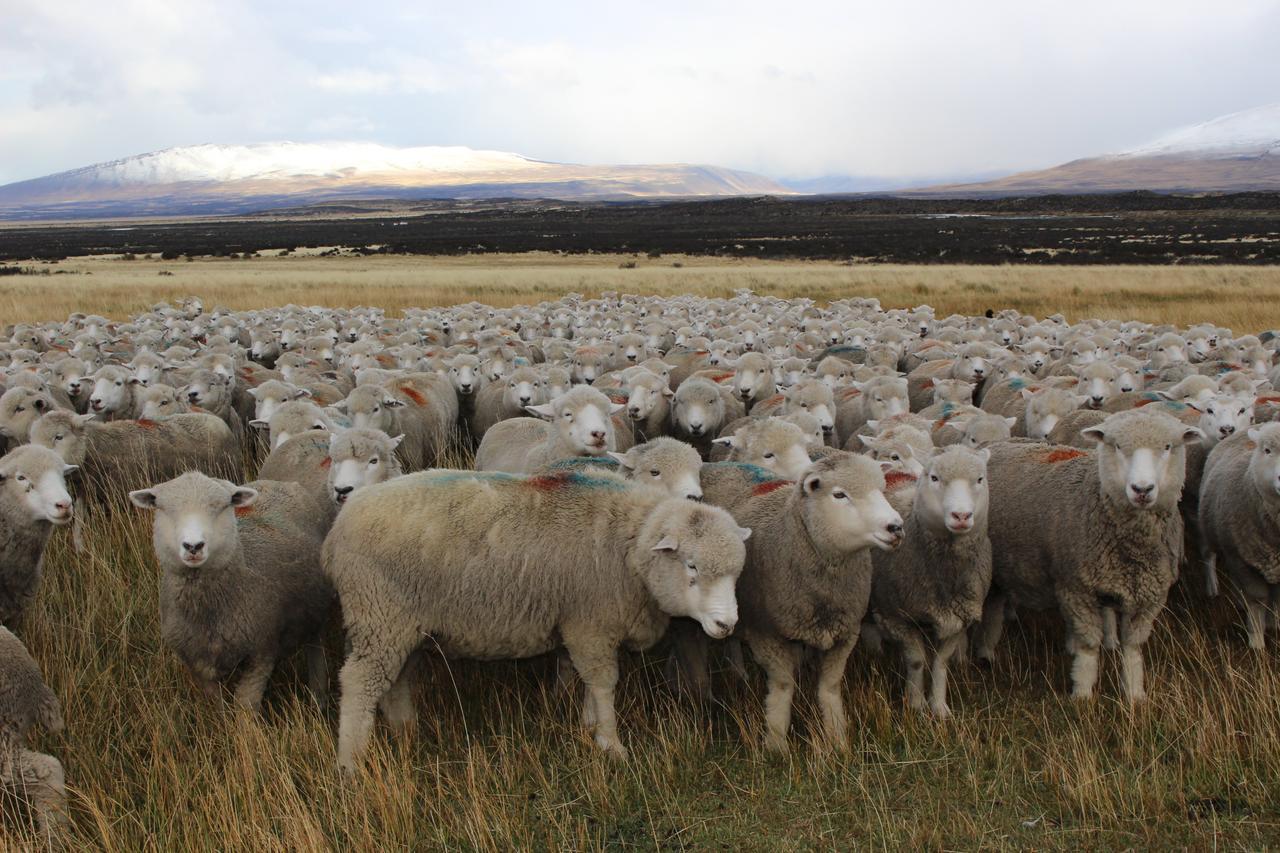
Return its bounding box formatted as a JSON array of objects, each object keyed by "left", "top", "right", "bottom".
[{"left": 129, "top": 471, "right": 257, "bottom": 569}]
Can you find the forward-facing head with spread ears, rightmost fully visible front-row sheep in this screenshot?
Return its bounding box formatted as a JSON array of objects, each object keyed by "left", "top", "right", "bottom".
[{"left": 1080, "top": 409, "right": 1204, "bottom": 510}]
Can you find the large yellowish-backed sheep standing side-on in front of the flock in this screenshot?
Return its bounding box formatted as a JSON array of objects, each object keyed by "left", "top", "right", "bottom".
[{"left": 323, "top": 471, "right": 750, "bottom": 772}]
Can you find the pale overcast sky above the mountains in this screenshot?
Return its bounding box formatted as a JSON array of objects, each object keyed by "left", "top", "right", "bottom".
[{"left": 0, "top": 0, "right": 1280, "bottom": 183}]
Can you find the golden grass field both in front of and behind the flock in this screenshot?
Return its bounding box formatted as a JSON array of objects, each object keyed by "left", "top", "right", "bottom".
[{"left": 0, "top": 259, "right": 1280, "bottom": 850}]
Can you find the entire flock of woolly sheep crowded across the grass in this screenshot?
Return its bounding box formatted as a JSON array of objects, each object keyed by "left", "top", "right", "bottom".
[{"left": 0, "top": 291, "right": 1280, "bottom": 825}]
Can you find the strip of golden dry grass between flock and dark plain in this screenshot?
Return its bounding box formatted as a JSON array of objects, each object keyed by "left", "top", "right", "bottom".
[{"left": 0, "top": 249, "right": 1280, "bottom": 332}]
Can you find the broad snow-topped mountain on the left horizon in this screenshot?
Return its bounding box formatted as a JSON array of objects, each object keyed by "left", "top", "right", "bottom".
[{"left": 0, "top": 142, "right": 787, "bottom": 219}]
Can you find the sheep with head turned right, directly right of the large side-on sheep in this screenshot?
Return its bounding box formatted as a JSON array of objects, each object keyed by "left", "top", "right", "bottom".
[{"left": 703, "top": 451, "right": 902, "bottom": 751}]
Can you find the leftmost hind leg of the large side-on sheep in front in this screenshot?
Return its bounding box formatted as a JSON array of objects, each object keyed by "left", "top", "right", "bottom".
[{"left": 338, "top": 637, "right": 416, "bottom": 776}]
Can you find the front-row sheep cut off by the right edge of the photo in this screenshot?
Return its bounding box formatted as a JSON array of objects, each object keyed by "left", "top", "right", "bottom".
[{"left": 1197, "top": 423, "right": 1280, "bottom": 651}]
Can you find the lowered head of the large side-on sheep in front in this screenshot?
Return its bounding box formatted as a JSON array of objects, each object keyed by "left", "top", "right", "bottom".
[{"left": 641, "top": 500, "right": 751, "bottom": 639}]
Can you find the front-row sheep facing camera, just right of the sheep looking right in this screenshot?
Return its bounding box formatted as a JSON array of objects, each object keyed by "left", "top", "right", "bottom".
[{"left": 872, "top": 447, "right": 991, "bottom": 719}]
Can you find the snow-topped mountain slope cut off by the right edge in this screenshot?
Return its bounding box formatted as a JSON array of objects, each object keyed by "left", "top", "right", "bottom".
[{"left": 914, "top": 104, "right": 1280, "bottom": 196}]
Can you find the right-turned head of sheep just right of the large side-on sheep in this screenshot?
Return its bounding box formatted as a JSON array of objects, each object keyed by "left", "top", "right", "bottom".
[{"left": 800, "top": 456, "right": 902, "bottom": 553}]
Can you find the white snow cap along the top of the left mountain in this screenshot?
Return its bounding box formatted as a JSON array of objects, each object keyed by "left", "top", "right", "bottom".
[{"left": 63, "top": 142, "right": 544, "bottom": 184}]
